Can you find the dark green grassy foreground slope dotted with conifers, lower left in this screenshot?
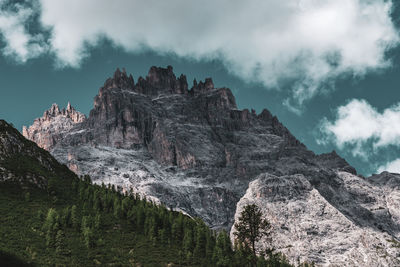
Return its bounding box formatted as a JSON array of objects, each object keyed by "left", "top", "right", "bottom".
[{"left": 0, "top": 120, "right": 289, "bottom": 266}]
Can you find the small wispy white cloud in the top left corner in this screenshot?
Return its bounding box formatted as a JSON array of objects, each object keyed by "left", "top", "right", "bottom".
[{"left": 0, "top": 1, "right": 46, "bottom": 63}]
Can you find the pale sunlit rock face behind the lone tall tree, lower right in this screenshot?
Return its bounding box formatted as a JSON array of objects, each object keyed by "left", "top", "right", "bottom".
[{"left": 231, "top": 172, "right": 400, "bottom": 266}]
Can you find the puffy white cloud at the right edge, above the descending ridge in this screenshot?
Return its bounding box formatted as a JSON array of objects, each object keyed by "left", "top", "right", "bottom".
[{"left": 318, "top": 99, "right": 400, "bottom": 158}]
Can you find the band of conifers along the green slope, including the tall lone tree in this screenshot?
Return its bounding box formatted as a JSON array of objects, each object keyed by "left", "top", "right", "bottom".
[{"left": 39, "top": 176, "right": 302, "bottom": 266}]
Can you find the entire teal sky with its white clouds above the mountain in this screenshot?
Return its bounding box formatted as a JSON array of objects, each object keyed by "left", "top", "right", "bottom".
[{"left": 0, "top": 0, "right": 400, "bottom": 176}]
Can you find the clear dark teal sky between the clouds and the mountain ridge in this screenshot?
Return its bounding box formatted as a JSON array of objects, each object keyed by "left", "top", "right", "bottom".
[{"left": 0, "top": 1, "right": 400, "bottom": 177}]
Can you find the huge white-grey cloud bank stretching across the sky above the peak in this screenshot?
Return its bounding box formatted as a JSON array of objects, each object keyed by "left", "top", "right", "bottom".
[{"left": 0, "top": 0, "right": 399, "bottom": 109}]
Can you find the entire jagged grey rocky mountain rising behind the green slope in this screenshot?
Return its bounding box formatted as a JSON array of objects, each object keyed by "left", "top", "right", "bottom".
[{"left": 23, "top": 66, "right": 400, "bottom": 266}]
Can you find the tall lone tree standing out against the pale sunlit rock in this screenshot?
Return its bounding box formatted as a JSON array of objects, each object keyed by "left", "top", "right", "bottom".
[{"left": 234, "top": 204, "right": 271, "bottom": 257}]
